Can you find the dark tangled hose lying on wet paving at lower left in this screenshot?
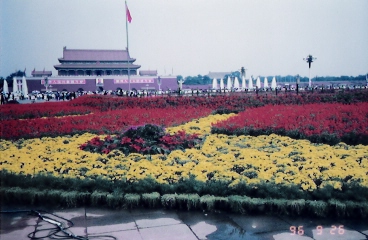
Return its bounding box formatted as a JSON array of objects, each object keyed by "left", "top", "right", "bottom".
[{"left": 0, "top": 210, "right": 116, "bottom": 240}]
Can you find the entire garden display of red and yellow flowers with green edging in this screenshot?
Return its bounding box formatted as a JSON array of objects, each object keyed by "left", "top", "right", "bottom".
[{"left": 0, "top": 92, "right": 368, "bottom": 216}]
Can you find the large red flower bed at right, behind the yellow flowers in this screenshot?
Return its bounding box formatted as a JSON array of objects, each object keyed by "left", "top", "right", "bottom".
[{"left": 213, "top": 102, "right": 368, "bottom": 145}]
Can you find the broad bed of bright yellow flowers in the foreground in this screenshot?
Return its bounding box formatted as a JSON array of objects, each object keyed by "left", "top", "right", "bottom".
[{"left": 0, "top": 115, "right": 368, "bottom": 200}]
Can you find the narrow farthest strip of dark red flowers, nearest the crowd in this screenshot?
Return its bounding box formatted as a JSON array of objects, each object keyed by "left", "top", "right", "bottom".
[{"left": 70, "top": 90, "right": 368, "bottom": 111}]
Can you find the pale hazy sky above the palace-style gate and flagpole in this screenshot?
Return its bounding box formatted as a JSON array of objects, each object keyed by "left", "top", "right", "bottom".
[{"left": 0, "top": 0, "right": 368, "bottom": 77}]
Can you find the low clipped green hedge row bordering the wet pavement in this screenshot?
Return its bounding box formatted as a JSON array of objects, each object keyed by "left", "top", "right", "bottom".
[{"left": 0, "top": 187, "right": 368, "bottom": 219}]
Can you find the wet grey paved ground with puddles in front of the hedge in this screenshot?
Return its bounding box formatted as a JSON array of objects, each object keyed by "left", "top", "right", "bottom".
[{"left": 0, "top": 207, "right": 368, "bottom": 240}]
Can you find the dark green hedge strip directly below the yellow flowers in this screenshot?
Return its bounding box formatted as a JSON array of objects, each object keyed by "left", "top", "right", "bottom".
[{"left": 0, "top": 171, "right": 368, "bottom": 202}]
